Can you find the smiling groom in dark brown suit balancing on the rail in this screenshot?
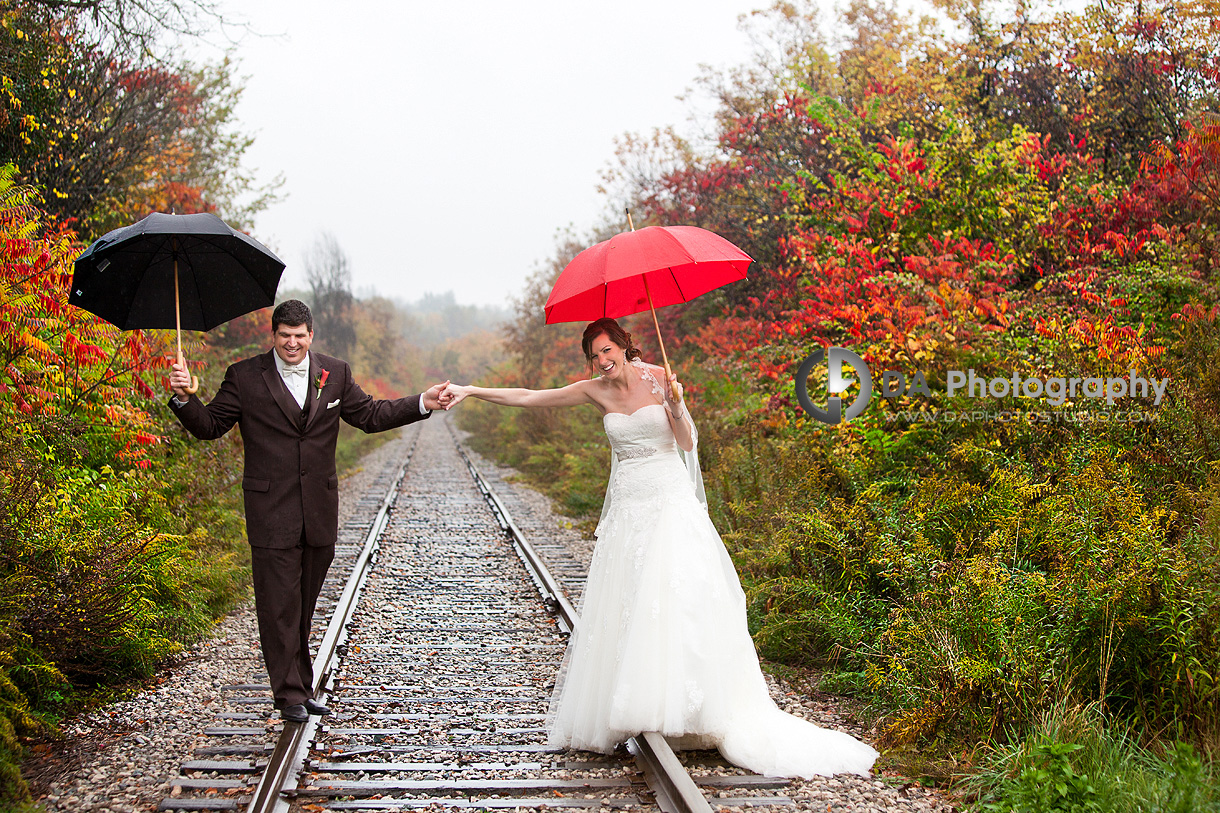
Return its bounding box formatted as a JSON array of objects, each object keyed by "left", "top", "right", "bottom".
[{"left": 170, "top": 299, "right": 449, "bottom": 723}]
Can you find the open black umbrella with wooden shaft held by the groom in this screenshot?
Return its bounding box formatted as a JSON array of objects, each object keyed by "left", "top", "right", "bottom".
[{"left": 68, "top": 212, "right": 284, "bottom": 392}]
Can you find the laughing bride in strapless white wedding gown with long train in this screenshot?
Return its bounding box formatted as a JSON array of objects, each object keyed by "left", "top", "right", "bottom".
[{"left": 447, "top": 319, "right": 877, "bottom": 779}]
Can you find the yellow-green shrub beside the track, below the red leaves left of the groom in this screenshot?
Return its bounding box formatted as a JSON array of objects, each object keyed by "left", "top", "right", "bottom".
[{"left": 0, "top": 419, "right": 245, "bottom": 802}]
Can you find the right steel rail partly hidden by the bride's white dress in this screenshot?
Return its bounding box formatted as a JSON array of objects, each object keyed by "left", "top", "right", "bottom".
[{"left": 448, "top": 424, "right": 711, "bottom": 813}]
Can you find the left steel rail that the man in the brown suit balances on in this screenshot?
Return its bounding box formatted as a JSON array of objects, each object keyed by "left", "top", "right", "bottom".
[{"left": 246, "top": 433, "right": 420, "bottom": 813}]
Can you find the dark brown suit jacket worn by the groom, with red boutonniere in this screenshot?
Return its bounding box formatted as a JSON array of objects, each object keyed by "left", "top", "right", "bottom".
[{"left": 170, "top": 350, "right": 431, "bottom": 548}]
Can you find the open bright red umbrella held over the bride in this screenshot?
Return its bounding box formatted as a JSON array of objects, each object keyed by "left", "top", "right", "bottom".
[{"left": 545, "top": 215, "right": 753, "bottom": 393}]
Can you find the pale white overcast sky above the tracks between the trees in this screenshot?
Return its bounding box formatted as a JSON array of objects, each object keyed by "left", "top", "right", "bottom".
[{"left": 201, "top": 0, "right": 764, "bottom": 304}]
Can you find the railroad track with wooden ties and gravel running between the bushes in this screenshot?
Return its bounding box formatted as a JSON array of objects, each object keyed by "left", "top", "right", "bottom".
[{"left": 159, "top": 416, "right": 792, "bottom": 813}]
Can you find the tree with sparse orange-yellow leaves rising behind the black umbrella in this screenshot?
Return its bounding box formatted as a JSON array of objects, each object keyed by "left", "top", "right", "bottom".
[{"left": 0, "top": 4, "right": 281, "bottom": 238}]
